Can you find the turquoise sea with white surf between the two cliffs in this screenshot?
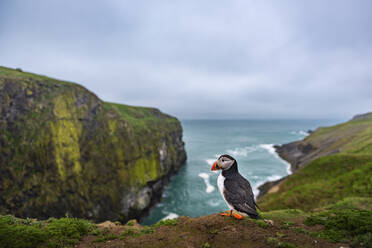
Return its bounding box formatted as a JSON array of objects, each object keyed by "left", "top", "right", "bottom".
[{"left": 142, "top": 120, "right": 338, "bottom": 225}]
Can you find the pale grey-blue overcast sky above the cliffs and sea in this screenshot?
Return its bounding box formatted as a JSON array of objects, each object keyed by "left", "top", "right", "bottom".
[{"left": 0, "top": 0, "right": 372, "bottom": 119}]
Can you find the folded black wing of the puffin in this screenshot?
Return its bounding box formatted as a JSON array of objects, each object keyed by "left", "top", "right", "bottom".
[{"left": 224, "top": 175, "right": 258, "bottom": 218}]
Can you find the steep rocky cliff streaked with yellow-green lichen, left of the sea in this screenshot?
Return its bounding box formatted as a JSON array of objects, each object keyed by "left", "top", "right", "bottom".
[{"left": 0, "top": 67, "right": 186, "bottom": 221}]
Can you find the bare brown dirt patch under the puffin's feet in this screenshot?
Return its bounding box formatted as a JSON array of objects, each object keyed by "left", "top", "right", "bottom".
[{"left": 76, "top": 214, "right": 348, "bottom": 248}]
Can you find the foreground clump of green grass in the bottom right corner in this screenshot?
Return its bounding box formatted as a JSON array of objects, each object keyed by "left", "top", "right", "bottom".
[{"left": 261, "top": 197, "right": 372, "bottom": 247}]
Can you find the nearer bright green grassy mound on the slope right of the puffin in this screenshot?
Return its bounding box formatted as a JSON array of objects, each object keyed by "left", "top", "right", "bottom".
[{"left": 259, "top": 154, "right": 372, "bottom": 211}]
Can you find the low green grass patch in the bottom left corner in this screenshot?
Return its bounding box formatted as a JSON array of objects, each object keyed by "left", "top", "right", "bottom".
[{"left": 0, "top": 215, "right": 95, "bottom": 248}]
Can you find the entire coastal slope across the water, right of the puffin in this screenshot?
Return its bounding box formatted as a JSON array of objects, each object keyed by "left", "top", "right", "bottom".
[{"left": 259, "top": 113, "right": 372, "bottom": 211}]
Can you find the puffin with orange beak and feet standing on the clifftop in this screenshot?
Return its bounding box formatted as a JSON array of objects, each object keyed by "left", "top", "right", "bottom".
[{"left": 211, "top": 154, "right": 259, "bottom": 220}]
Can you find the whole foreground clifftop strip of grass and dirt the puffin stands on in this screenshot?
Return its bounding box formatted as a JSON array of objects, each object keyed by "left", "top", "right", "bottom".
[{"left": 0, "top": 198, "right": 372, "bottom": 248}]
